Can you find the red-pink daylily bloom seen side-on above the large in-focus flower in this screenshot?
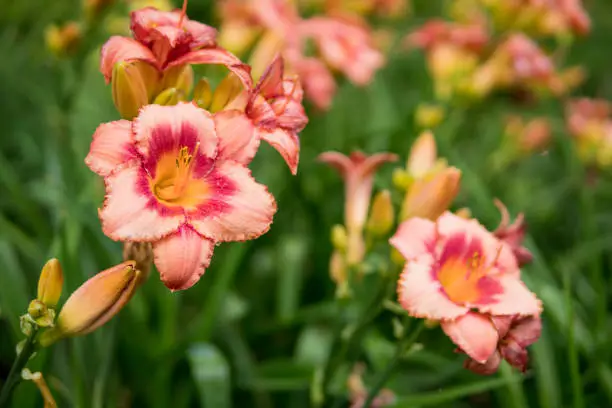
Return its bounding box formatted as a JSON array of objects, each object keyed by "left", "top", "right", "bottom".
[{"left": 100, "top": 7, "right": 252, "bottom": 89}]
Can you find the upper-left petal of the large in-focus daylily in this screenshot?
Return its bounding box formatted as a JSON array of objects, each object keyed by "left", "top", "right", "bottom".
[{"left": 85, "top": 120, "right": 136, "bottom": 177}]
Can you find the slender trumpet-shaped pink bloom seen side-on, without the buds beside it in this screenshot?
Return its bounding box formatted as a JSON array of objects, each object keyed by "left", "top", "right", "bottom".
[{"left": 319, "top": 151, "right": 397, "bottom": 265}]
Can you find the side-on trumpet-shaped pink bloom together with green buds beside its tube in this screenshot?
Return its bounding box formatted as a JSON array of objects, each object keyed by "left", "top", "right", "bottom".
[{"left": 319, "top": 151, "right": 397, "bottom": 295}]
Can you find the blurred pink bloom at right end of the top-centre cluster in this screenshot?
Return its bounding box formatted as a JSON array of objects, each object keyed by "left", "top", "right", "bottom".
[{"left": 298, "top": 17, "right": 385, "bottom": 85}]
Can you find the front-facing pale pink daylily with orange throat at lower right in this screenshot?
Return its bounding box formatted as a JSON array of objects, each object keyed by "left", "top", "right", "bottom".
[{"left": 389, "top": 212, "right": 542, "bottom": 364}]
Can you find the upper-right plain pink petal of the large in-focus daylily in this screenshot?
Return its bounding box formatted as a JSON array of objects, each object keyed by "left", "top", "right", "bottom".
[{"left": 214, "top": 110, "right": 259, "bottom": 165}]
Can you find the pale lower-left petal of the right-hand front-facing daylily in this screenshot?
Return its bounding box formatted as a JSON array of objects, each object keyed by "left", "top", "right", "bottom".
[{"left": 397, "top": 256, "right": 469, "bottom": 320}]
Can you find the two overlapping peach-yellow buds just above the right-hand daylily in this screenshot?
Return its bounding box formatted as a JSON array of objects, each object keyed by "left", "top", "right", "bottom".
[{"left": 400, "top": 132, "right": 461, "bottom": 220}]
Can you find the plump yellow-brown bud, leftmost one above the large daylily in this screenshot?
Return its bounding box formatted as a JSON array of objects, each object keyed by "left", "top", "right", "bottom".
[{"left": 112, "top": 62, "right": 149, "bottom": 120}]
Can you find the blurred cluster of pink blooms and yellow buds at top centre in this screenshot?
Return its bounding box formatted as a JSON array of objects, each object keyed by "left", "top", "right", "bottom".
[{"left": 219, "top": 0, "right": 384, "bottom": 110}]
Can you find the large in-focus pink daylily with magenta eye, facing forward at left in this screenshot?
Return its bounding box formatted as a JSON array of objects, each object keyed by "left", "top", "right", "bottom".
[{"left": 86, "top": 103, "right": 276, "bottom": 290}]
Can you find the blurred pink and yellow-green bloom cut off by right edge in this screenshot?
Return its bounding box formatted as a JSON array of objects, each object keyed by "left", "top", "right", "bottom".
[{"left": 566, "top": 98, "right": 612, "bottom": 168}]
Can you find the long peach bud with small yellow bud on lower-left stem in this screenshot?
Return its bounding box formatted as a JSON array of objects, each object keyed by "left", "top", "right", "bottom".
[{"left": 21, "top": 259, "right": 140, "bottom": 347}]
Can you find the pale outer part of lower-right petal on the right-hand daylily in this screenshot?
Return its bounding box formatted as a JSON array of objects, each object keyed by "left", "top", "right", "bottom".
[{"left": 478, "top": 275, "right": 542, "bottom": 316}]
